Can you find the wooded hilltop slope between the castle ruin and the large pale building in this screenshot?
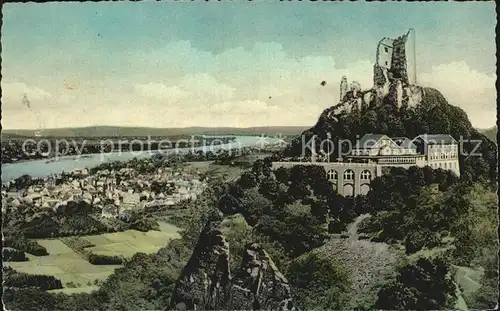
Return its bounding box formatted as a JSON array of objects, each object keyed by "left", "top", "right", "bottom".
[{"left": 282, "top": 88, "right": 497, "bottom": 183}]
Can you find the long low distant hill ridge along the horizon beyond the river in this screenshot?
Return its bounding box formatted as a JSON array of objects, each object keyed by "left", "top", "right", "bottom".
[{"left": 2, "top": 126, "right": 307, "bottom": 137}]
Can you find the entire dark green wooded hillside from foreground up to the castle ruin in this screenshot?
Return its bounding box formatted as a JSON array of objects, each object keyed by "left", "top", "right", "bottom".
[{"left": 4, "top": 88, "right": 498, "bottom": 310}]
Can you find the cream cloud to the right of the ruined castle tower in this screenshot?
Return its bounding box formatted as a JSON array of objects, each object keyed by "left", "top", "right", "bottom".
[{"left": 418, "top": 61, "right": 496, "bottom": 128}]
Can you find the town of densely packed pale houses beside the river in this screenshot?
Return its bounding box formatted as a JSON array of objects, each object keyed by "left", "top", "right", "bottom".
[{"left": 2, "top": 160, "right": 208, "bottom": 218}]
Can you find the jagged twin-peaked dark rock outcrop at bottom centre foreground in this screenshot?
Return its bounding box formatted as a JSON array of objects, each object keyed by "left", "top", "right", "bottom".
[{"left": 169, "top": 222, "right": 294, "bottom": 310}]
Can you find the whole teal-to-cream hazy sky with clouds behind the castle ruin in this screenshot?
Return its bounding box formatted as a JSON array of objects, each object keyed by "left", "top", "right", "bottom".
[{"left": 2, "top": 0, "right": 496, "bottom": 129}]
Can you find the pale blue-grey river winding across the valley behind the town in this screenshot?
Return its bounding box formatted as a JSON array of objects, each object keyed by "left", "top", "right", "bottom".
[{"left": 2, "top": 136, "right": 280, "bottom": 182}]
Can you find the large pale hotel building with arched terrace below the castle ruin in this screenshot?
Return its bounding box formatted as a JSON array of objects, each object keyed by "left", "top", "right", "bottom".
[{"left": 272, "top": 134, "right": 460, "bottom": 196}]
